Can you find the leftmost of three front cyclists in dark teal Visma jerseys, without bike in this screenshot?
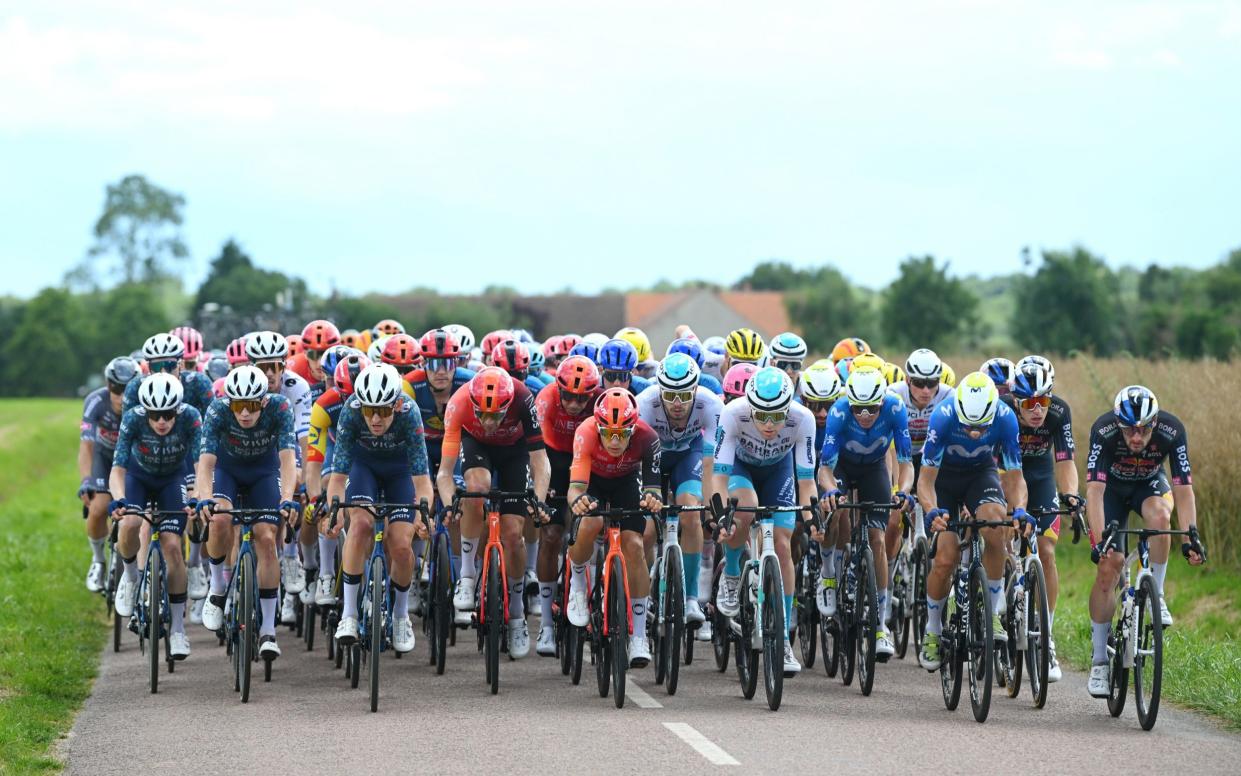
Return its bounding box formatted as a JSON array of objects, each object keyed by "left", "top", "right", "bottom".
[{"left": 108, "top": 372, "right": 202, "bottom": 661}]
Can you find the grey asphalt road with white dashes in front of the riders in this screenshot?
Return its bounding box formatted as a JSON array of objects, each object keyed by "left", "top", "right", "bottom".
[{"left": 62, "top": 610, "right": 1241, "bottom": 776}]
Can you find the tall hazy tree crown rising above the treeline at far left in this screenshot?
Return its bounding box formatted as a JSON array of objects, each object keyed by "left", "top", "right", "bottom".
[{"left": 69, "top": 175, "right": 190, "bottom": 283}]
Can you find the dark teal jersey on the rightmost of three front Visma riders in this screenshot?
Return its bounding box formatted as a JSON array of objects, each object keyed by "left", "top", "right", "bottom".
[{"left": 331, "top": 394, "right": 431, "bottom": 474}]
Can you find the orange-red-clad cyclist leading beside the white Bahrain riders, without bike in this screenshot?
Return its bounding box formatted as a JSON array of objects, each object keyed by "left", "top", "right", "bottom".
[{"left": 567, "top": 389, "right": 663, "bottom": 668}]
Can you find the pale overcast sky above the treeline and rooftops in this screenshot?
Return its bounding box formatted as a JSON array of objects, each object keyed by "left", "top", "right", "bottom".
[{"left": 0, "top": 0, "right": 1241, "bottom": 294}]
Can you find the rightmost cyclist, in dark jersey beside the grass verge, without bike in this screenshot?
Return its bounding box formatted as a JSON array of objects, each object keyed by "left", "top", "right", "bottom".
[{"left": 1086, "top": 385, "right": 1206, "bottom": 698}]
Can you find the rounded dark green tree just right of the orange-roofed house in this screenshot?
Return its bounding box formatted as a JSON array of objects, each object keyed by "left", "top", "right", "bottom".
[{"left": 881, "top": 256, "right": 978, "bottom": 350}]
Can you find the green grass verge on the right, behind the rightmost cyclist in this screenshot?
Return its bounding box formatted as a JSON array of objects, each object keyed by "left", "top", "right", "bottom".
[{"left": 1055, "top": 541, "right": 1241, "bottom": 730}]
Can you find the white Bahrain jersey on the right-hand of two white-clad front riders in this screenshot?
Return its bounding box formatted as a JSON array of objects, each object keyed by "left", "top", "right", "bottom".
[{"left": 715, "top": 399, "right": 814, "bottom": 479}]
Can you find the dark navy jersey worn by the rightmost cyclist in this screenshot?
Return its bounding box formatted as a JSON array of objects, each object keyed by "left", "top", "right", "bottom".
[{"left": 1086, "top": 410, "right": 1193, "bottom": 485}]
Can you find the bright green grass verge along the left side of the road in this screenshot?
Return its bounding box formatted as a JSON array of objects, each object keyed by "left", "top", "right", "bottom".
[{"left": 0, "top": 400, "right": 105, "bottom": 774}]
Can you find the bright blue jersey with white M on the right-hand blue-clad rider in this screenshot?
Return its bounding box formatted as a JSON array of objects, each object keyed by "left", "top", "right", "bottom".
[{"left": 922, "top": 399, "right": 1021, "bottom": 471}]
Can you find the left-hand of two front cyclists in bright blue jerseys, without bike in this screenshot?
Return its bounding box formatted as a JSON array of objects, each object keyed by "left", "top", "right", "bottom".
[{"left": 817, "top": 366, "right": 913, "bottom": 662}]
